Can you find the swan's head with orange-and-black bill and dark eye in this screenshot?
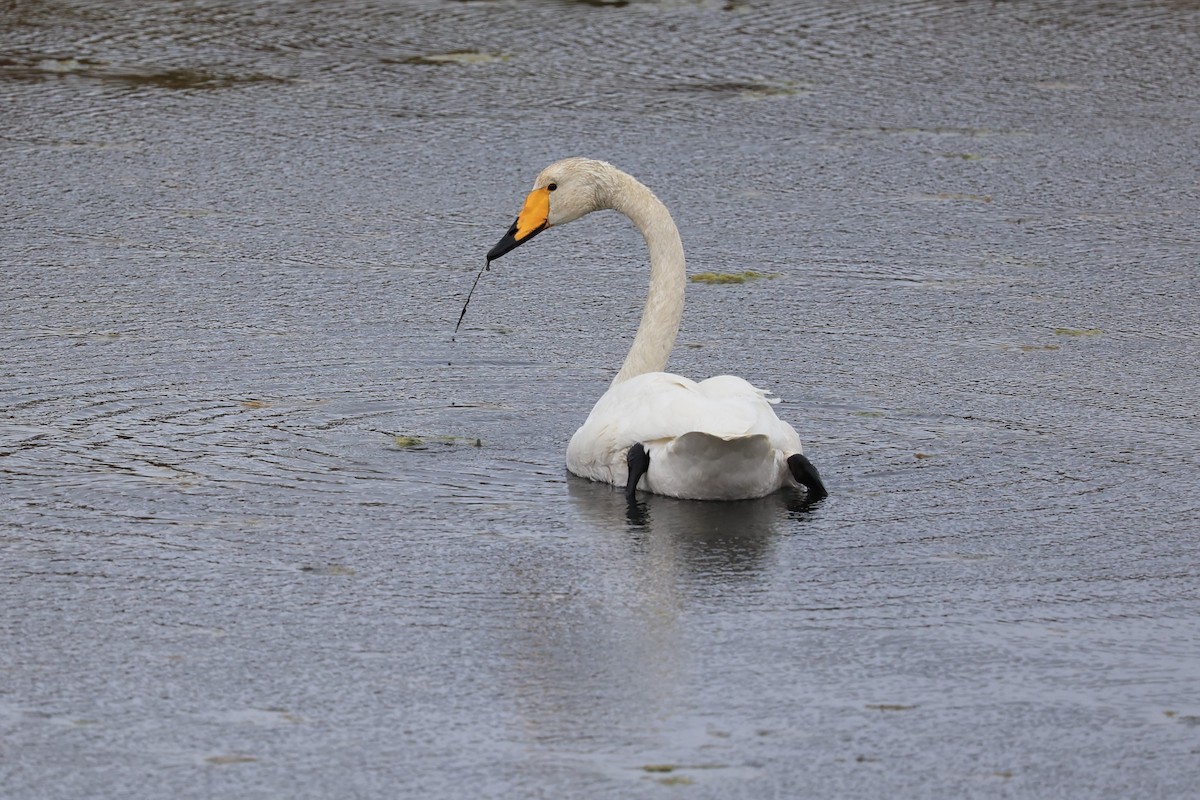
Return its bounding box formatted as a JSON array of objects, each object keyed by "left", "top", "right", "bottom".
[{"left": 487, "top": 158, "right": 623, "bottom": 261}]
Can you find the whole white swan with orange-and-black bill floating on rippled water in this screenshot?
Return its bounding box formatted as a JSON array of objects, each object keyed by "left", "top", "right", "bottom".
[{"left": 487, "top": 158, "right": 826, "bottom": 500}]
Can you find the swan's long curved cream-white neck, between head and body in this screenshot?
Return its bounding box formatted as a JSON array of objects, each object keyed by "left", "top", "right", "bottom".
[{"left": 611, "top": 173, "right": 686, "bottom": 384}]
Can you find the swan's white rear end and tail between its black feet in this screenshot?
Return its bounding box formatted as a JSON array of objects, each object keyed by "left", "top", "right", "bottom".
[{"left": 642, "top": 431, "right": 787, "bottom": 500}]
